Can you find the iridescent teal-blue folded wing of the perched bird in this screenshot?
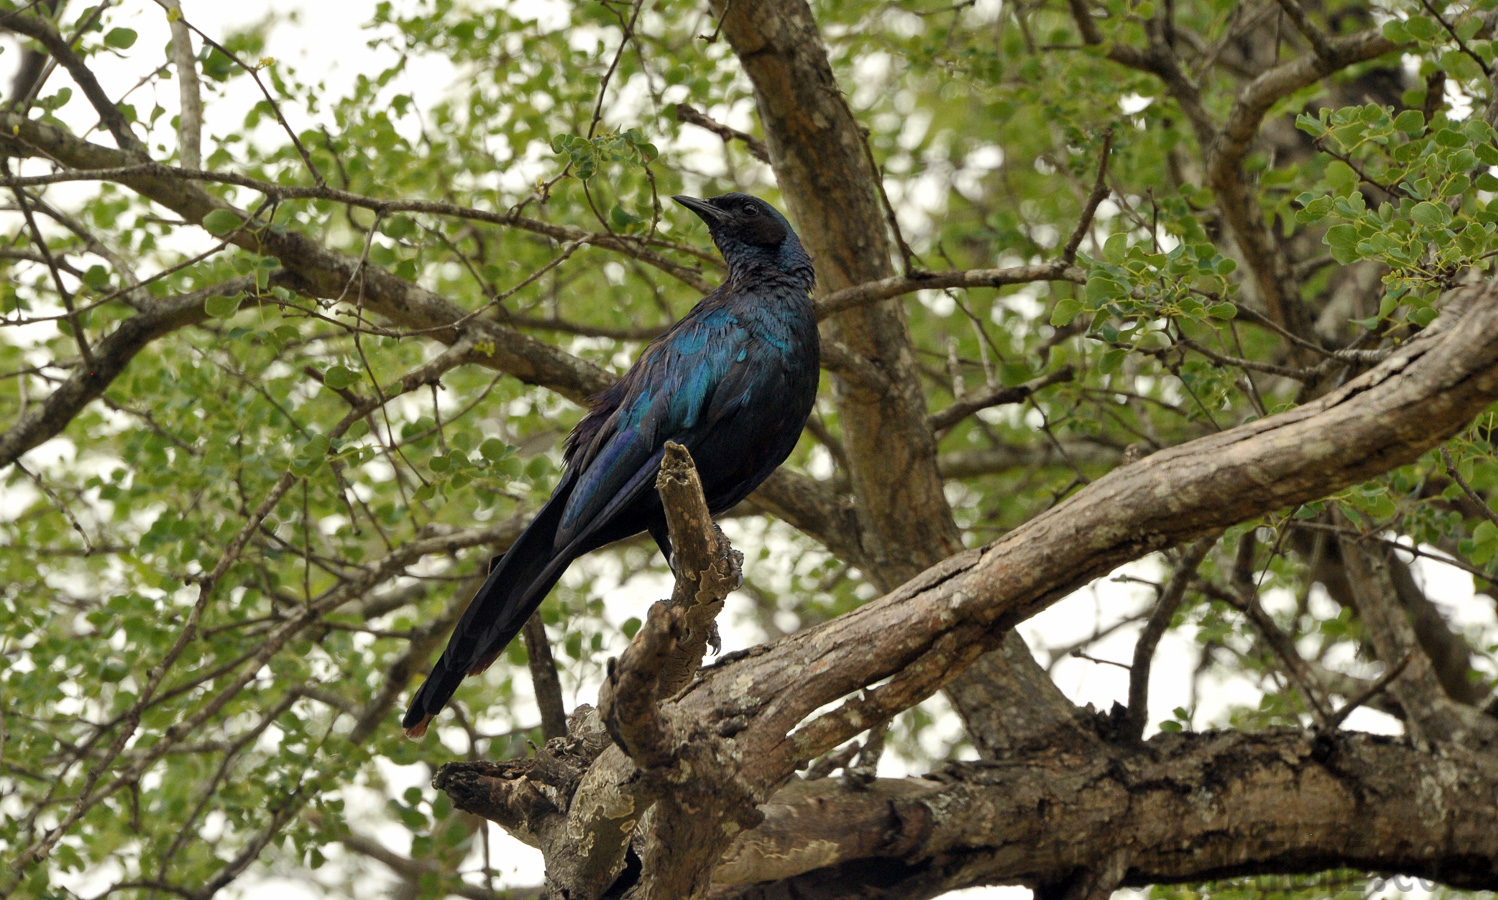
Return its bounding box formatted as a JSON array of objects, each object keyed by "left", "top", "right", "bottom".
[{"left": 556, "top": 305, "right": 748, "bottom": 550}]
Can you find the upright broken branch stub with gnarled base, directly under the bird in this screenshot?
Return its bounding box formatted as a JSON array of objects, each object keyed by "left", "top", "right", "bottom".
[{"left": 434, "top": 443, "right": 753, "bottom": 899}]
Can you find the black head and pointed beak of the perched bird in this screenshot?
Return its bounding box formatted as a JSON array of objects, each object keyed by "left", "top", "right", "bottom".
[{"left": 671, "top": 193, "right": 815, "bottom": 291}]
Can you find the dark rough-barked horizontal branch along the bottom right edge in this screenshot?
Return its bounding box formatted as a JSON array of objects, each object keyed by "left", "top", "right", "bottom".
[{"left": 712, "top": 731, "right": 1498, "bottom": 900}]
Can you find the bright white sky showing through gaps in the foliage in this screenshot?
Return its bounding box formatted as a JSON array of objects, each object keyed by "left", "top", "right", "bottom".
[{"left": 14, "top": 0, "right": 1498, "bottom": 900}]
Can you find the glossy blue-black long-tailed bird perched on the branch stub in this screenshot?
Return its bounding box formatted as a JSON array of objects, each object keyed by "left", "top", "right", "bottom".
[{"left": 401, "top": 193, "right": 821, "bottom": 737}]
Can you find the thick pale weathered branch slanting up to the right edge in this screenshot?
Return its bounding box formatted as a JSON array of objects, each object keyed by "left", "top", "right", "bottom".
[{"left": 679, "top": 286, "right": 1498, "bottom": 773}]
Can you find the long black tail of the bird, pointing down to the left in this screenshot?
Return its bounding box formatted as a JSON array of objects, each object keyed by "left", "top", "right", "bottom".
[{"left": 400, "top": 476, "right": 577, "bottom": 737}]
